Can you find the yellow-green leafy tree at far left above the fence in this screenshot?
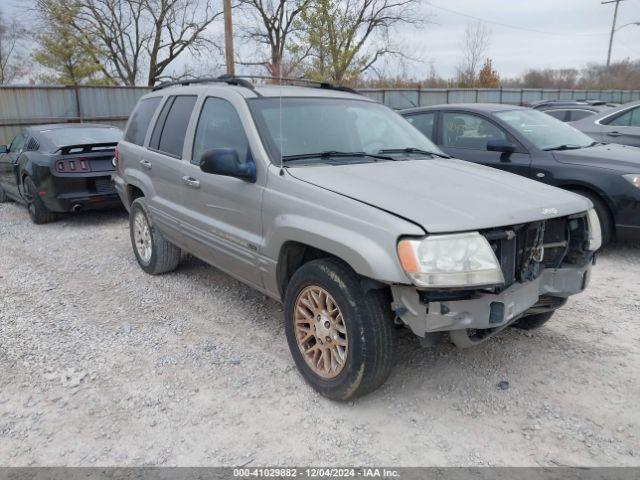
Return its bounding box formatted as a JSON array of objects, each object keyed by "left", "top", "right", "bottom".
[{"left": 33, "top": 0, "right": 112, "bottom": 85}]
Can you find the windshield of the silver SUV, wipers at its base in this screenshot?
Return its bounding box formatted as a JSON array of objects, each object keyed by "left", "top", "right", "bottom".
[{"left": 249, "top": 97, "right": 444, "bottom": 164}]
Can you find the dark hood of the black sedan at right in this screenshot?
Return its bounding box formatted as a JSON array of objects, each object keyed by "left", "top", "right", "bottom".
[{"left": 553, "top": 143, "right": 640, "bottom": 174}]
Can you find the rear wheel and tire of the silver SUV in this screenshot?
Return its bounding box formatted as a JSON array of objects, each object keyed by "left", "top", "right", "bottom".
[{"left": 129, "top": 198, "right": 181, "bottom": 275}]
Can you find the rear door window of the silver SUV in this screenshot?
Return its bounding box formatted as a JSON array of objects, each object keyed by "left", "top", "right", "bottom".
[{"left": 149, "top": 95, "right": 198, "bottom": 158}]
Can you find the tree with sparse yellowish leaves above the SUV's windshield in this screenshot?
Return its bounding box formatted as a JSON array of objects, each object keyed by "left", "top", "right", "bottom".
[{"left": 298, "top": 0, "right": 428, "bottom": 83}]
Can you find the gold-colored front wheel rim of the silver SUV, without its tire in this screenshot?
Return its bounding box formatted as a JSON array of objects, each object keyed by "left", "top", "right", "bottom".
[{"left": 293, "top": 285, "right": 349, "bottom": 379}]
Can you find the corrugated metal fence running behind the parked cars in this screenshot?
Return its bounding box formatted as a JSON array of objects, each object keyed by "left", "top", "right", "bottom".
[{"left": 0, "top": 86, "right": 640, "bottom": 143}]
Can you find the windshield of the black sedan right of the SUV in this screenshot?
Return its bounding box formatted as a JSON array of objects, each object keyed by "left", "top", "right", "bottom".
[{"left": 496, "top": 109, "right": 594, "bottom": 150}]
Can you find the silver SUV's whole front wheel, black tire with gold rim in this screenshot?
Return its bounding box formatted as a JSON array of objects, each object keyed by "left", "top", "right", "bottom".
[{"left": 284, "top": 259, "right": 396, "bottom": 400}]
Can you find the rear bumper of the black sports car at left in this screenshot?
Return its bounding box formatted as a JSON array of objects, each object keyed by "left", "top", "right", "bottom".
[{"left": 40, "top": 175, "right": 122, "bottom": 212}]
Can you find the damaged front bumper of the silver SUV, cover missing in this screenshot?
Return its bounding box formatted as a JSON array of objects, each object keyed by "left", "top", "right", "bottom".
[{"left": 391, "top": 263, "right": 591, "bottom": 347}]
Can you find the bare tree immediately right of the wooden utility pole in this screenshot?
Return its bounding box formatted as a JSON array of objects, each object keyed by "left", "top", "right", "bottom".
[{"left": 239, "top": 0, "right": 312, "bottom": 77}]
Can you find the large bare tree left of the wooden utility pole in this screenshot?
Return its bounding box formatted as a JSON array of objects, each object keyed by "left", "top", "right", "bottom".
[{"left": 64, "top": 0, "right": 222, "bottom": 85}]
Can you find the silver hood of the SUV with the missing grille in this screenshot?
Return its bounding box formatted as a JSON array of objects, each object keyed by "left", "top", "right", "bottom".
[{"left": 287, "top": 159, "right": 591, "bottom": 233}]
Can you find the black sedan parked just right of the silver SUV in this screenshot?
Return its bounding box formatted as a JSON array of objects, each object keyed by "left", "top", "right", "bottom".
[{"left": 401, "top": 103, "right": 640, "bottom": 243}]
